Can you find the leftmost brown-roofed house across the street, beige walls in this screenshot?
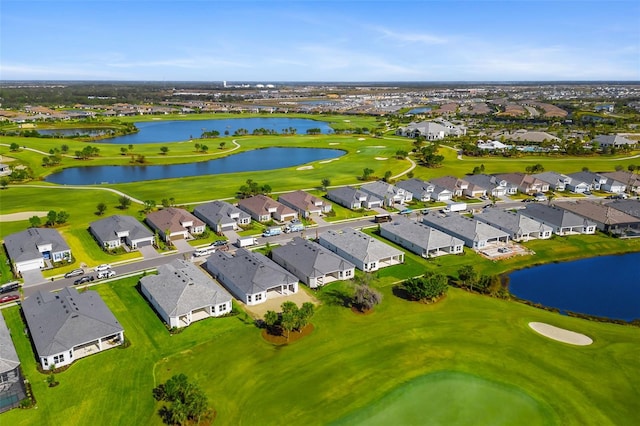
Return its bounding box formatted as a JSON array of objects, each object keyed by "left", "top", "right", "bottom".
[{"left": 145, "top": 207, "right": 206, "bottom": 241}]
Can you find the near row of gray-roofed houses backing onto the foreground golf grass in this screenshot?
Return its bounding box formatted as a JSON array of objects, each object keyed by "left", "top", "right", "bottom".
[{"left": 6, "top": 200, "right": 640, "bottom": 388}]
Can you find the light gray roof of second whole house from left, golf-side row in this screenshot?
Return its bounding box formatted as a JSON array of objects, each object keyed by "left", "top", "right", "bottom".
[{"left": 140, "top": 259, "right": 232, "bottom": 317}]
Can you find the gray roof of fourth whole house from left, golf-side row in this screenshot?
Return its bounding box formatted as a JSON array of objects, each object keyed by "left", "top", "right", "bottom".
[{"left": 272, "top": 237, "right": 355, "bottom": 278}]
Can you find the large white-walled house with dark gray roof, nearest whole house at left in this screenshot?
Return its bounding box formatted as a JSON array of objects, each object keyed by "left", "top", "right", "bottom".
[{"left": 22, "top": 287, "right": 124, "bottom": 370}]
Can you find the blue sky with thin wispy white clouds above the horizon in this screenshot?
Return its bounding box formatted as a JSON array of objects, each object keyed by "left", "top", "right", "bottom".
[{"left": 0, "top": 0, "right": 640, "bottom": 83}]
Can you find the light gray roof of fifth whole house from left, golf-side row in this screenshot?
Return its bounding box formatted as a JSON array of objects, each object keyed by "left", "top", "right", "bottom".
[{"left": 320, "top": 228, "right": 404, "bottom": 263}]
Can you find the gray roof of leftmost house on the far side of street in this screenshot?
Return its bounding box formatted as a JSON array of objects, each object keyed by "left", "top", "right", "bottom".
[{"left": 4, "top": 228, "right": 69, "bottom": 263}]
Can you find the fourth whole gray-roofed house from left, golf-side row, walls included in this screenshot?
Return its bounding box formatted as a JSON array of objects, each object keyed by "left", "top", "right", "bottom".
[{"left": 271, "top": 237, "right": 355, "bottom": 288}]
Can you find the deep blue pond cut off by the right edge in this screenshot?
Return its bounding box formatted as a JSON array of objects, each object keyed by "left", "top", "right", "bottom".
[{"left": 509, "top": 253, "right": 640, "bottom": 321}]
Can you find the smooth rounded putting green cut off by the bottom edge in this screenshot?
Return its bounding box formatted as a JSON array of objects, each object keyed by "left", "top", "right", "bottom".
[{"left": 334, "top": 371, "right": 555, "bottom": 426}]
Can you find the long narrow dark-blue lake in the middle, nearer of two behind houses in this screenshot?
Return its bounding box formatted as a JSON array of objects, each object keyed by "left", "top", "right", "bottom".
[{"left": 45, "top": 148, "right": 345, "bottom": 185}]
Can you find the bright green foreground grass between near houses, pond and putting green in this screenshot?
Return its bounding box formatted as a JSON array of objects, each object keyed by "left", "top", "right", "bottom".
[{"left": 0, "top": 248, "right": 640, "bottom": 425}]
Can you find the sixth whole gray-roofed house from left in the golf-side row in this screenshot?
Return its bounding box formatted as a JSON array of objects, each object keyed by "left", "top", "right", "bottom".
[{"left": 380, "top": 216, "right": 464, "bottom": 258}]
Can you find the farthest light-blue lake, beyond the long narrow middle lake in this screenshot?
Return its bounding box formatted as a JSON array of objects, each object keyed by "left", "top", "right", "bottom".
[{"left": 102, "top": 117, "right": 333, "bottom": 145}]
